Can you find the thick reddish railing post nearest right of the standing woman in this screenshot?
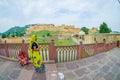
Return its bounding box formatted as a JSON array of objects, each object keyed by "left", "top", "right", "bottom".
[{"left": 49, "top": 40, "right": 57, "bottom": 62}]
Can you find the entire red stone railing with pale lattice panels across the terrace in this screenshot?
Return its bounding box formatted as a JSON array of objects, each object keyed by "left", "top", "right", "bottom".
[{"left": 0, "top": 41, "right": 117, "bottom": 62}]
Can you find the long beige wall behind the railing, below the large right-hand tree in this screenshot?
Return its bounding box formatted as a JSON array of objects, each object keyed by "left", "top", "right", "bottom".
[{"left": 82, "top": 34, "right": 120, "bottom": 44}]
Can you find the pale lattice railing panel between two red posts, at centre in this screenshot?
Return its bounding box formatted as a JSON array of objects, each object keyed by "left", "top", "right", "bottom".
[{"left": 56, "top": 46, "right": 78, "bottom": 62}]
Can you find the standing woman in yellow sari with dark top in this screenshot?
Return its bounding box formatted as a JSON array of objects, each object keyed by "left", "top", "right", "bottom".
[{"left": 30, "top": 35, "right": 44, "bottom": 72}]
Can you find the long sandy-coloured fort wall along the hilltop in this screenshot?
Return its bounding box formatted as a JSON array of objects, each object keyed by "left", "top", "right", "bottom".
[{"left": 26, "top": 24, "right": 81, "bottom": 34}]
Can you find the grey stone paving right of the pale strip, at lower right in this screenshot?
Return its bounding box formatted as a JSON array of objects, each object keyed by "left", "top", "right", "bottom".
[{"left": 57, "top": 48, "right": 120, "bottom": 80}]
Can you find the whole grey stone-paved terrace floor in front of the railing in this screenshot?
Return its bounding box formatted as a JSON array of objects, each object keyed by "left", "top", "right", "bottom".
[{"left": 0, "top": 48, "right": 120, "bottom": 80}]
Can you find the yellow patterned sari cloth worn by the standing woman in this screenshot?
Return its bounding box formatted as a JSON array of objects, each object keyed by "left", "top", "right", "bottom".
[{"left": 29, "top": 35, "right": 43, "bottom": 68}]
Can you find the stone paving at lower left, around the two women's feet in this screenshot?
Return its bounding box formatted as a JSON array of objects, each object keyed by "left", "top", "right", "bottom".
[{"left": 0, "top": 59, "right": 46, "bottom": 80}]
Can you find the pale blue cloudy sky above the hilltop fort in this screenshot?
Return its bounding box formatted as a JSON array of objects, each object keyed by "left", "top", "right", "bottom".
[{"left": 0, "top": 0, "right": 120, "bottom": 32}]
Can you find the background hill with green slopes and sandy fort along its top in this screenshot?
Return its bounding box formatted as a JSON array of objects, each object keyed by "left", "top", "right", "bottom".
[{"left": 0, "top": 24, "right": 119, "bottom": 38}]
